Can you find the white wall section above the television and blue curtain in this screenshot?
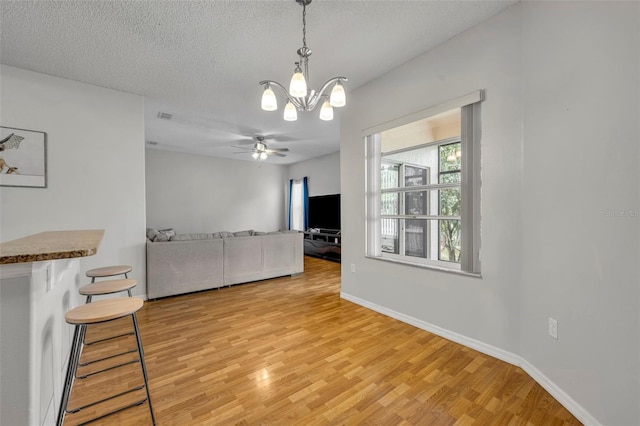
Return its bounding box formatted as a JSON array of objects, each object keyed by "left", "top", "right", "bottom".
[{"left": 289, "top": 151, "right": 340, "bottom": 197}]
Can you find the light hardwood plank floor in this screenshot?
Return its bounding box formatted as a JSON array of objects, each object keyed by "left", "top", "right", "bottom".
[{"left": 65, "top": 258, "right": 580, "bottom": 426}]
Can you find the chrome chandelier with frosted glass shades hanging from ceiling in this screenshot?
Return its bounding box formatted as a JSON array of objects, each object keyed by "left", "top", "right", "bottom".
[{"left": 259, "top": 0, "right": 347, "bottom": 121}]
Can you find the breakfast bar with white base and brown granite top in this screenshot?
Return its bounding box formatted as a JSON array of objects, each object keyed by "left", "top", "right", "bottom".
[{"left": 0, "top": 229, "right": 104, "bottom": 425}]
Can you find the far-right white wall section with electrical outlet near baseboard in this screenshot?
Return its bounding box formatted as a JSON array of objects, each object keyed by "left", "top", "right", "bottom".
[{"left": 520, "top": 2, "right": 640, "bottom": 425}]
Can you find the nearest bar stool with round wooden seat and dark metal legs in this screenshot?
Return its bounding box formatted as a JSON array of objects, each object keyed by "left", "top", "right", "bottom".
[{"left": 56, "top": 297, "right": 156, "bottom": 426}]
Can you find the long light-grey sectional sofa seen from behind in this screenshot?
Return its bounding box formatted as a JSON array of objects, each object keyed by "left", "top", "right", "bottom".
[{"left": 147, "top": 231, "right": 304, "bottom": 299}]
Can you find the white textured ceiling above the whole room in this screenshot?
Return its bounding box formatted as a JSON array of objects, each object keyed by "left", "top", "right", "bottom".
[{"left": 0, "top": 0, "right": 516, "bottom": 164}]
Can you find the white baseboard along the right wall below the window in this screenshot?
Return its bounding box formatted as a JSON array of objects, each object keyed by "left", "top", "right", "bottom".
[{"left": 340, "top": 292, "right": 602, "bottom": 426}]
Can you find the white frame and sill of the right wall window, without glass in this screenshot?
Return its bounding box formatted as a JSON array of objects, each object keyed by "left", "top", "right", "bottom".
[{"left": 362, "top": 90, "right": 484, "bottom": 276}]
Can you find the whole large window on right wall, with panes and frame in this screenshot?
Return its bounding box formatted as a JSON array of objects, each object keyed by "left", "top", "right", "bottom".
[{"left": 364, "top": 92, "right": 482, "bottom": 274}]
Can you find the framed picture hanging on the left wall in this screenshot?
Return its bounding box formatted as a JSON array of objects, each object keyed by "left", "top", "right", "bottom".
[{"left": 0, "top": 126, "right": 47, "bottom": 188}]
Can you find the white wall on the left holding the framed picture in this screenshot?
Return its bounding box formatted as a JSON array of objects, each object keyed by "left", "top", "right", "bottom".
[{"left": 0, "top": 65, "right": 146, "bottom": 294}]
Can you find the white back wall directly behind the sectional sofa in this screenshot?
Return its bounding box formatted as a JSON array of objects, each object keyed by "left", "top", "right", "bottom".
[{"left": 146, "top": 149, "right": 287, "bottom": 233}]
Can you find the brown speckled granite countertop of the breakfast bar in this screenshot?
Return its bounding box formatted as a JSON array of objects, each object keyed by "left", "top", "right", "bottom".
[{"left": 0, "top": 229, "right": 104, "bottom": 265}]
